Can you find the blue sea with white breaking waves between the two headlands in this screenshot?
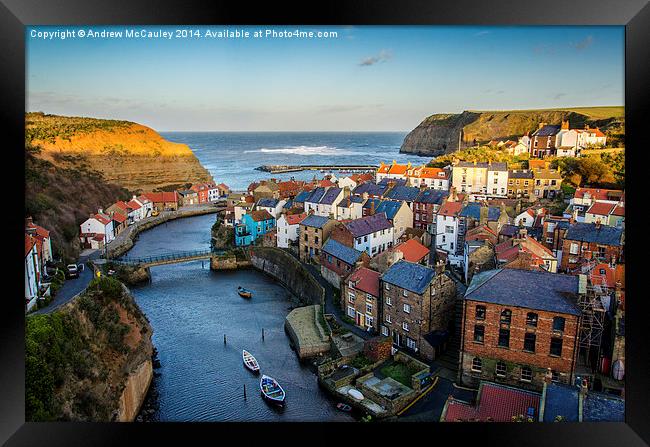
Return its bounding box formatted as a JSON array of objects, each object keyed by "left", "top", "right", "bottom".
[{"left": 160, "top": 132, "right": 431, "bottom": 191}]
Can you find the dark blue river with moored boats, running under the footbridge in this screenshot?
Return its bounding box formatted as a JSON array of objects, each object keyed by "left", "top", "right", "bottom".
[{"left": 129, "top": 215, "right": 352, "bottom": 422}]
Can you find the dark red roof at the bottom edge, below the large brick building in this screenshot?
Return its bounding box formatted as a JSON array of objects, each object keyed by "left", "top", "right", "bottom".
[{"left": 445, "top": 383, "right": 540, "bottom": 422}]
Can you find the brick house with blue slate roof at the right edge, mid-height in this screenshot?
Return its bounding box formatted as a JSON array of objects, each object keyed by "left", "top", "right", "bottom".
[{"left": 560, "top": 222, "right": 623, "bottom": 272}]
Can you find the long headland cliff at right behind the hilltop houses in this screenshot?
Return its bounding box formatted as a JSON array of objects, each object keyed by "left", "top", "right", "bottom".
[{"left": 400, "top": 107, "right": 624, "bottom": 156}]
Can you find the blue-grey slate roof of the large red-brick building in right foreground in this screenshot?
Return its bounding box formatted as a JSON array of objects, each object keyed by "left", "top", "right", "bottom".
[{"left": 465, "top": 269, "right": 580, "bottom": 315}]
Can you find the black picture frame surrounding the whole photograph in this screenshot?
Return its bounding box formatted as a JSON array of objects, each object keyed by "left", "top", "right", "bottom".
[{"left": 0, "top": 0, "right": 650, "bottom": 446}]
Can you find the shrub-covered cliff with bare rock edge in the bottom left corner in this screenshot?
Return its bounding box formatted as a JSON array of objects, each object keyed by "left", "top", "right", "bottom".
[{"left": 25, "top": 278, "right": 153, "bottom": 422}]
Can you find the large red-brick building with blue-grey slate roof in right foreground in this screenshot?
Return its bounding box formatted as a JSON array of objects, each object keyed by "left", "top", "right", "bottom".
[{"left": 459, "top": 269, "right": 581, "bottom": 390}]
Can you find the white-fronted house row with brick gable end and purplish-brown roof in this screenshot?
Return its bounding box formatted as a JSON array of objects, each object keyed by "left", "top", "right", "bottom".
[{"left": 331, "top": 213, "right": 395, "bottom": 257}]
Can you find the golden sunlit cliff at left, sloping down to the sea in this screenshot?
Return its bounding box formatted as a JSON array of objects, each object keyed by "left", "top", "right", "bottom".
[{"left": 25, "top": 113, "right": 212, "bottom": 191}]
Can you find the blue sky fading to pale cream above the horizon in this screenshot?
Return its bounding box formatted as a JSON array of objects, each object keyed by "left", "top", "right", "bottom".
[{"left": 26, "top": 25, "right": 624, "bottom": 131}]
